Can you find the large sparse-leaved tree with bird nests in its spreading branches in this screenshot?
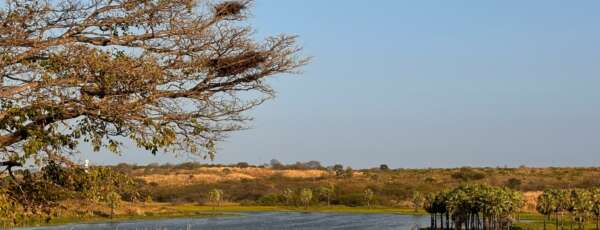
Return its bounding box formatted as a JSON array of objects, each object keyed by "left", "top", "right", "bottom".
[{"left": 0, "top": 0, "right": 307, "bottom": 171}]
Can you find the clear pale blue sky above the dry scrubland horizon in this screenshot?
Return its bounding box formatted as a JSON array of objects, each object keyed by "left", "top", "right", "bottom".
[{"left": 79, "top": 0, "right": 600, "bottom": 168}]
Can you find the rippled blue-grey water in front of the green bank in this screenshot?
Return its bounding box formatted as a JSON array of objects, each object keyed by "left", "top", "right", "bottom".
[{"left": 19, "top": 212, "right": 429, "bottom": 230}]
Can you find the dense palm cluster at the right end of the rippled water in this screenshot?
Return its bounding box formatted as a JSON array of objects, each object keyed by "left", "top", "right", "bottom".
[{"left": 423, "top": 185, "right": 523, "bottom": 229}]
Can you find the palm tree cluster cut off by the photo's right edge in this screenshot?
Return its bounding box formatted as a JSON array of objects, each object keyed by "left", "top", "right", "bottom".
[{"left": 536, "top": 188, "right": 600, "bottom": 229}]
